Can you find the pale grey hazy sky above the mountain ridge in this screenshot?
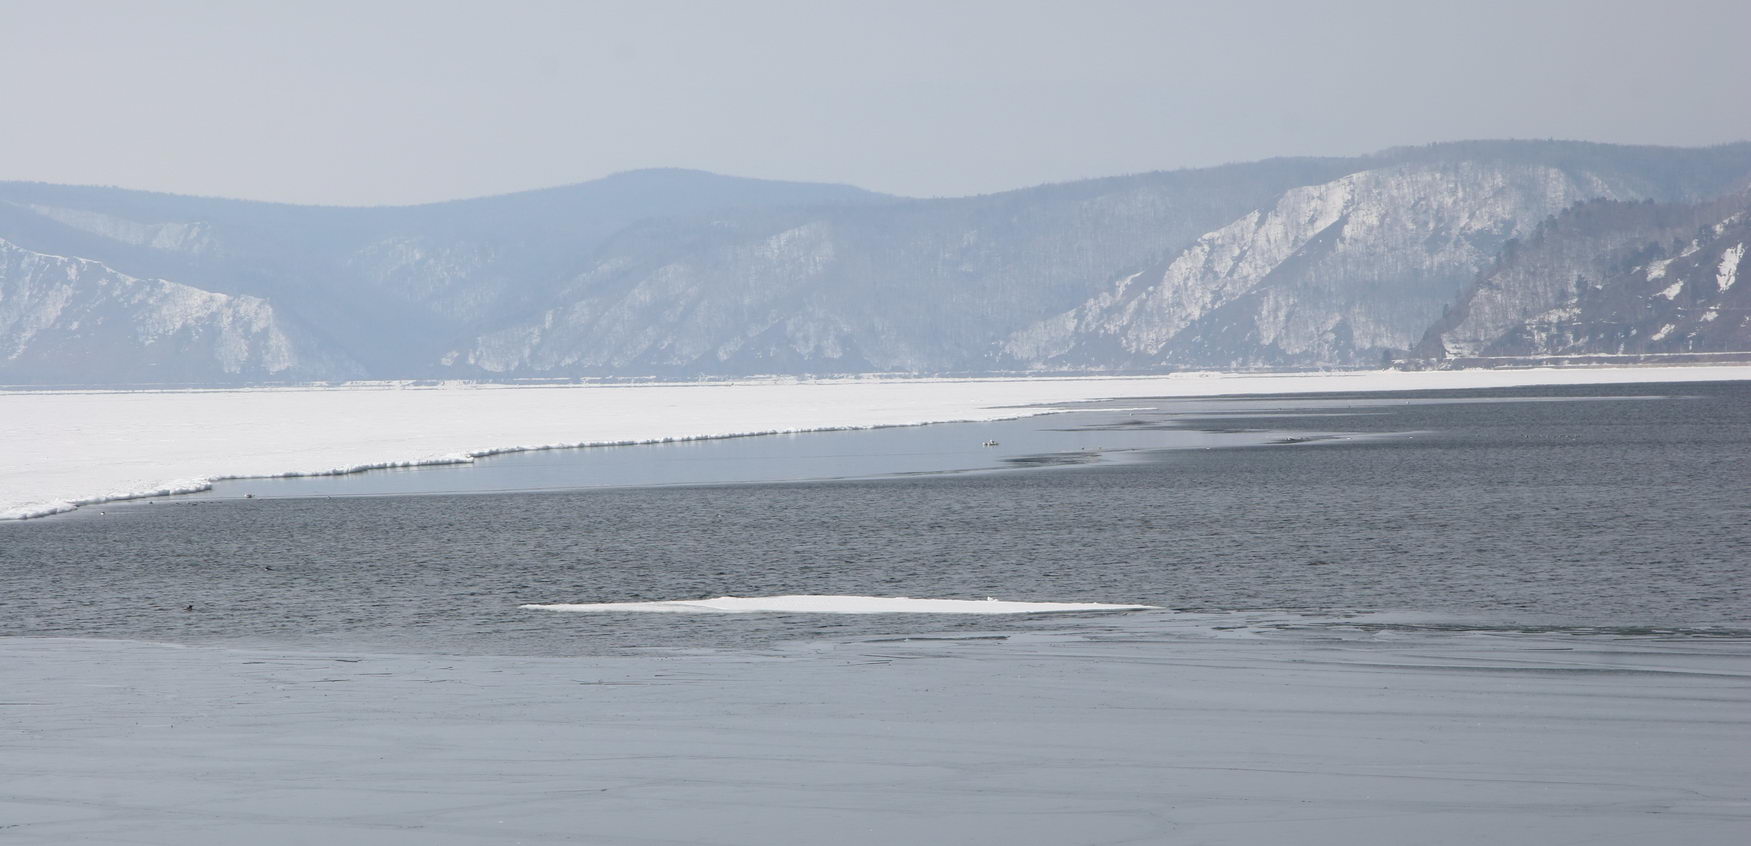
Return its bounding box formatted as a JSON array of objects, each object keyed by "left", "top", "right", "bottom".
[{"left": 0, "top": 0, "right": 1751, "bottom": 205}]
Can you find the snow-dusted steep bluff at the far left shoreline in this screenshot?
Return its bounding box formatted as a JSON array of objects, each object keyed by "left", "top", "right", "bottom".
[{"left": 0, "top": 240, "right": 357, "bottom": 384}]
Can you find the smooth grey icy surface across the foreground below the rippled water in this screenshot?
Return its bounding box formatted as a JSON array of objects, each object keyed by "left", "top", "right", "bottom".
[{"left": 0, "top": 613, "right": 1751, "bottom": 846}]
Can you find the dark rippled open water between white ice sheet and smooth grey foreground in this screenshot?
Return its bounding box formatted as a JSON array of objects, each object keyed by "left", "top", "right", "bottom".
[{"left": 0, "top": 384, "right": 1751, "bottom": 655}]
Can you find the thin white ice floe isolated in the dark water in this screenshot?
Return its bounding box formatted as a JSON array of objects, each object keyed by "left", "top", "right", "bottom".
[{"left": 522, "top": 596, "right": 1159, "bottom": 615}]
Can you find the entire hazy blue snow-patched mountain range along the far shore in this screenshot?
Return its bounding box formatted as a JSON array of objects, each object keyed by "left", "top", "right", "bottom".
[{"left": 0, "top": 142, "right": 1751, "bottom": 385}]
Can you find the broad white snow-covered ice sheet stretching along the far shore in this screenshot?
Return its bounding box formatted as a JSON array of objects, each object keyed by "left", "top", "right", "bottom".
[{"left": 10, "top": 366, "right": 1751, "bottom": 518}]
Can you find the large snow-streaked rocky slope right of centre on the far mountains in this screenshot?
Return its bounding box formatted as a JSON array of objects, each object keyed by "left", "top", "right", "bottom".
[{"left": 1003, "top": 161, "right": 1634, "bottom": 368}]
